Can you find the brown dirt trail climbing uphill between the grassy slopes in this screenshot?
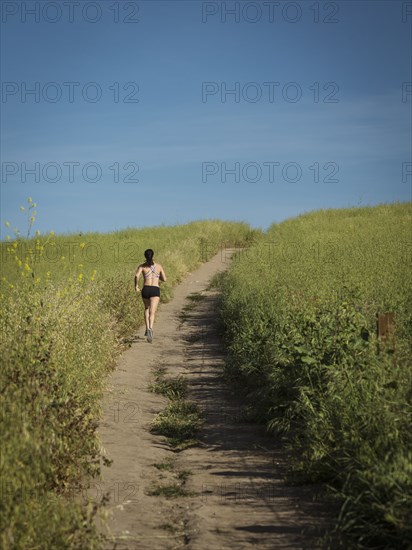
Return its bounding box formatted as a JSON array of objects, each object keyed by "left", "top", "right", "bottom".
[{"left": 96, "top": 251, "right": 327, "bottom": 550}]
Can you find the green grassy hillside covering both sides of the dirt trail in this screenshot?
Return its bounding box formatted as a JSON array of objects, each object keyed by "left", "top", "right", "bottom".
[{"left": 0, "top": 202, "right": 412, "bottom": 550}]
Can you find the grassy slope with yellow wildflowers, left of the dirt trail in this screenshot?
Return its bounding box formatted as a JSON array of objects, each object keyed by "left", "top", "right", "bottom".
[{"left": 0, "top": 210, "right": 251, "bottom": 550}]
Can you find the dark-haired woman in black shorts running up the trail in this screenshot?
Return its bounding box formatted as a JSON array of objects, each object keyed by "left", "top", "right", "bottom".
[{"left": 134, "top": 248, "right": 166, "bottom": 342}]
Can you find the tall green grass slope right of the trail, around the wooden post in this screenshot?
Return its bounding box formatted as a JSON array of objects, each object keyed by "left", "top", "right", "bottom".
[{"left": 217, "top": 203, "right": 412, "bottom": 549}]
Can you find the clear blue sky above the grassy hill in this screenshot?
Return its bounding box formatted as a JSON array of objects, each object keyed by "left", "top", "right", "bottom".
[{"left": 0, "top": 0, "right": 412, "bottom": 238}]
